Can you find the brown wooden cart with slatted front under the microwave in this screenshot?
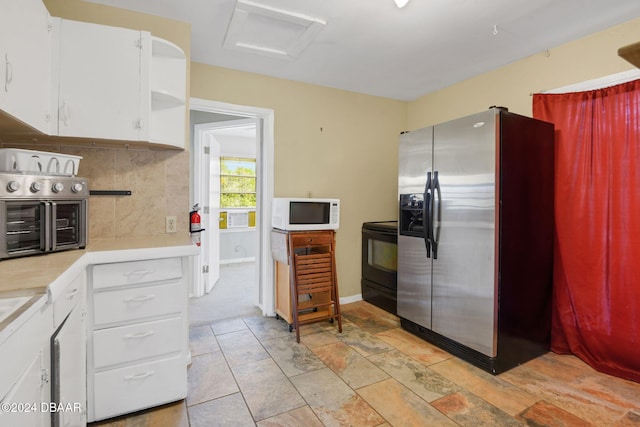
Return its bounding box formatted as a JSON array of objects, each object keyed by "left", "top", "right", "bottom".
[{"left": 271, "top": 230, "right": 342, "bottom": 342}]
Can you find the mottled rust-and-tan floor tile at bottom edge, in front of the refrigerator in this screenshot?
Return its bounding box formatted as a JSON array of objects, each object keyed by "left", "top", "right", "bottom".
[{"left": 431, "top": 391, "right": 521, "bottom": 427}]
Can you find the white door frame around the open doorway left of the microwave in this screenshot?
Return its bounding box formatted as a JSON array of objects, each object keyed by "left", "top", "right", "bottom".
[{"left": 189, "top": 98, "right": 275, "bottom": 316}]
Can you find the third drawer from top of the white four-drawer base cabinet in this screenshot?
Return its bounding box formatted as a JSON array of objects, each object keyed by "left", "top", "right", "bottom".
[{"left": 93, "top": 317, "right": 187, "bottom": 368}]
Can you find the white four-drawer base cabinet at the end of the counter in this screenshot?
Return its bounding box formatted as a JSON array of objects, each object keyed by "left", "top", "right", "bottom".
[{"left": 87, "top": 257, "right": 188, "bottom": 421}]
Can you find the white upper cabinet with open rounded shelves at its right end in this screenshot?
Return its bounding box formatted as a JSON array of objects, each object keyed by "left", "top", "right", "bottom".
[{"left": 51, "top": 20, "right": 187, "bottom": 149}]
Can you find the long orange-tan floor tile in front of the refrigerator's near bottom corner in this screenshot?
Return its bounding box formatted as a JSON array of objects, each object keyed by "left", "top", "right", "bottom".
[{"left": 429, "top": 358, "right": 538, "bottom": 416}]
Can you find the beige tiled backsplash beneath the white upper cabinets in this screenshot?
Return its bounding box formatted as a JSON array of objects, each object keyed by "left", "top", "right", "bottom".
[{"left": 1, "top": 144, "right": 190, "bottom": 240}]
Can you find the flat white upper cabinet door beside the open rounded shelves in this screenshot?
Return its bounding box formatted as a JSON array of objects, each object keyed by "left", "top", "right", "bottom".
[{"left": 58, "top": 19, "right": 142, "bottom": 140}]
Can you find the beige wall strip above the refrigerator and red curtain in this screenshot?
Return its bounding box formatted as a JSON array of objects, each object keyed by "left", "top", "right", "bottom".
[{"left": 407, "top": 18, "right": 640, "bottom": 129}]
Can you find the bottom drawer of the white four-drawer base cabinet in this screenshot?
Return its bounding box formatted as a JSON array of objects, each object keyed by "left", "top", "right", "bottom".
[{"left": 94, "top": 356, "right": 187, "bottom": 420}]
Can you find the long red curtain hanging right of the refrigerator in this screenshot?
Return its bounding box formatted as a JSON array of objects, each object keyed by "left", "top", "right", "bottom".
[{"left": 533, "top": 80, "right": 640, "bottom": 382}]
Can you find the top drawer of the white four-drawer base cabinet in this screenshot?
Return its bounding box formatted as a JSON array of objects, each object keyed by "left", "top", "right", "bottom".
[{"left": 93, "top": 258, "right": 182, "bottom": 289}]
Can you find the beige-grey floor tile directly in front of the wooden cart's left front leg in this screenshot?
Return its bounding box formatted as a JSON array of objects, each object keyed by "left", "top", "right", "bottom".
[{"left": 262, "top": 336, "right": 325, "bottom": 377}]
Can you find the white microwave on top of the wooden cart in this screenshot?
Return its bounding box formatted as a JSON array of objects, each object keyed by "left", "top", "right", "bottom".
[{"left": 271, "top": 197, "right": 340, "bottom": 231}]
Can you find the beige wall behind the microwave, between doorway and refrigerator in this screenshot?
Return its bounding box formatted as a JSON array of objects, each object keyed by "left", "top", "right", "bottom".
[{"left": 191, "top": 63, "right": 407, "bottom": 296}]
